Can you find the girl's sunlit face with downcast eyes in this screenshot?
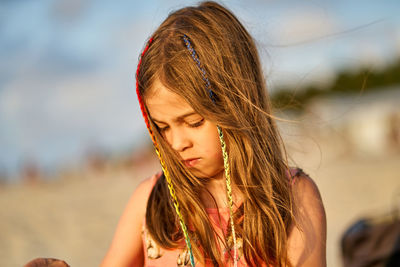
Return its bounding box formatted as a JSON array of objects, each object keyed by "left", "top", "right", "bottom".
[{"left": 146, "top": 80, "right": 224, "bottom": 178}]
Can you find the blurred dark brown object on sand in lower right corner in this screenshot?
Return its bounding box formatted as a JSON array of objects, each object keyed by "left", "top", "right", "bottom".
[{"left": 341, "top": 212, "right": 400, "bottom": 267}]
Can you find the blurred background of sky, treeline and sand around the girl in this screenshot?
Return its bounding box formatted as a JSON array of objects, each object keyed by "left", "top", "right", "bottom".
[{"left": 0, "top": 0, "right": 400, "bottom": 266}]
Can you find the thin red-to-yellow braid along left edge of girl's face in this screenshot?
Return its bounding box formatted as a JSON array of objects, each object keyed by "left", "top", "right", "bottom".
[{"left": 136, "top": 38, "right": 195, "bottom": 267}]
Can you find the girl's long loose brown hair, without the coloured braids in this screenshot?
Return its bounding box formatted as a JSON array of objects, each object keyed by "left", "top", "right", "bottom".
[{"left": 137, "top": 2, "right": 294, "bottom": 266}]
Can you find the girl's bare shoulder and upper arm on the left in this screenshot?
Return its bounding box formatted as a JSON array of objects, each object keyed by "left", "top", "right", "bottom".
[{"left": 101, "top": 176, "right": 155, "bottom": 267}]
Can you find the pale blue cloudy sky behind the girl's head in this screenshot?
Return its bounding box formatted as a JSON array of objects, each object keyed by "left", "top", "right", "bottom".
[{"left": 0, "top": 0, "right": 400, "bottom": 180}]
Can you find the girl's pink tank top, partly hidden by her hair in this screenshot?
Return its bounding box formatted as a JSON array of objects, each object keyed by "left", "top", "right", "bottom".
[{"left": 142, "top": 168, "right": 301, "bottom": 267}]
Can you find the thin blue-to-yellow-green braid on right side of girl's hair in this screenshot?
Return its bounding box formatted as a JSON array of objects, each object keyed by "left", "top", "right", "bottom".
[{"left": 182, "top": 34, "right": 238, "bottom": 267}]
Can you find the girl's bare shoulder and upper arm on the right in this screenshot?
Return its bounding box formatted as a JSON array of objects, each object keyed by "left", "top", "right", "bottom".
[{"left": 288, "top": 173, "right": 326, "bottom": 267}]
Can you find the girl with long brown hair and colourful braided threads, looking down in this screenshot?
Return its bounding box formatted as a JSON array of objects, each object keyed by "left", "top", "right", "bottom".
[{"left": 102, "top": 2, "right": 326, "bottom": 267}]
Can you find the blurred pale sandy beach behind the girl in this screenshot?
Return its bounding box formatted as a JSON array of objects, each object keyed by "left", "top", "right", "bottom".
[{"left": 0, "top": 134, "right": 400, "bottom": 267}]
